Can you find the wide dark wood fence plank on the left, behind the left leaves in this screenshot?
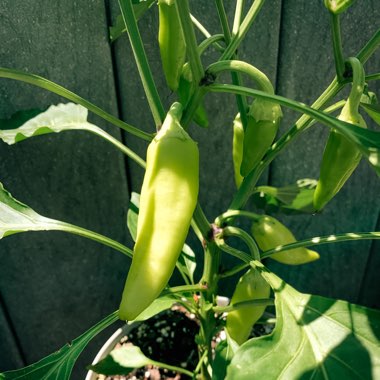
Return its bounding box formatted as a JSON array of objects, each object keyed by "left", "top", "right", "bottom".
[{"left": 0, "top": 0, "right": 130, "bottom": 378}]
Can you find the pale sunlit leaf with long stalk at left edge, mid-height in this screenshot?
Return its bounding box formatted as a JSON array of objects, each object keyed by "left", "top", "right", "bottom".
[{"left": 0, "top": 182, "right": 132, "bottom": 256}]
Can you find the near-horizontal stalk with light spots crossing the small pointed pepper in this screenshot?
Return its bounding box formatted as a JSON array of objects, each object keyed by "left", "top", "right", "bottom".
[{"left": 261, "top": 231, "right": 380, "bottom": 259}]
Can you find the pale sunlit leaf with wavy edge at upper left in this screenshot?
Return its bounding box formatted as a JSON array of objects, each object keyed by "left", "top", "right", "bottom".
[{"left": 0, "top": 103, "right": 104, "bottom": 145}]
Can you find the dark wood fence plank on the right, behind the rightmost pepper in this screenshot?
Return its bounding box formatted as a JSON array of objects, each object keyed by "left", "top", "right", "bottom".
[{"left": 270, "top": 0, "right": 380, "bottom": 304}]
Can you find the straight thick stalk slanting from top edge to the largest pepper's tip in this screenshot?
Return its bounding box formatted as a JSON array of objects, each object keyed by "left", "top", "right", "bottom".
[{"left": 118, "top": 0, "right": 165, "bottom": 129}]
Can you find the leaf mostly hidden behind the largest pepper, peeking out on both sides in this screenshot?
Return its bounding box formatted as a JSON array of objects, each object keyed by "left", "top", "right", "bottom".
[{"left": 127, "top": 192, "right": 196, "bottom": 284}]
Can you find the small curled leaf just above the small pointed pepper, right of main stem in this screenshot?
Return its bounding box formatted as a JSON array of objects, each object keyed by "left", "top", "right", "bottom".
[{"left": 252, "top": 178, "right": 317, "bottom": 214}]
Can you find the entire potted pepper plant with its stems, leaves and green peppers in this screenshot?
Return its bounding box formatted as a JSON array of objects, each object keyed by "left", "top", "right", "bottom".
[{"left": 0, "top": 0, "right": 380, "bottom": 379}]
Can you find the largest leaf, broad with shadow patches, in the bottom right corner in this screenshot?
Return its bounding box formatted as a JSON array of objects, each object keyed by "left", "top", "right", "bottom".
[{"left": 226, "top": 262, "right": 380, "bottom": 380}]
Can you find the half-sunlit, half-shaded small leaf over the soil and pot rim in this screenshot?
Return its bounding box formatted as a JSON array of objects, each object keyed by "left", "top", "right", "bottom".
[{"left": 88, "top": 345, "right": 155, "bottom": 376}]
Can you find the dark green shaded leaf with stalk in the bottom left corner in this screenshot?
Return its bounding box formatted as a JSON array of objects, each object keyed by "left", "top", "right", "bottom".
[{"left": 0, "top": 311, "right": 118, "bottom": 380}]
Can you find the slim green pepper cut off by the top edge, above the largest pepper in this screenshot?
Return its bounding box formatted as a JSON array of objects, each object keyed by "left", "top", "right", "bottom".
[{"left": 158, "top": 0, "right": 186, "bottom": 91}]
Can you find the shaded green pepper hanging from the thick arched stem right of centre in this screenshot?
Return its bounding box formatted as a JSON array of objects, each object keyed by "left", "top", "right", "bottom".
[{"left": 240, "top": 99, "right": 282, "bottom": 177}]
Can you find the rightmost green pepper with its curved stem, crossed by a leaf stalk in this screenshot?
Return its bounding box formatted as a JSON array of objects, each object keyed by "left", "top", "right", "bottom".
[{"left": 313, "top": 58, "right": 367, "bottom": 211}]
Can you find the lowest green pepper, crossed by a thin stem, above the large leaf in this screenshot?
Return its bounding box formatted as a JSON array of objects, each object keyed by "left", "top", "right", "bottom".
[{"left": 226, "top": 268, "right": 270, "bottom": 345}]
